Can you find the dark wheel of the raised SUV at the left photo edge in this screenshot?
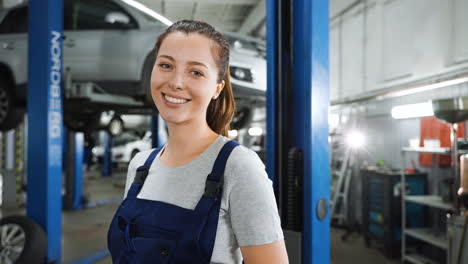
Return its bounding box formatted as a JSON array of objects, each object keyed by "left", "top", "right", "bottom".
[{"left": 0, "top": 79, "right": 25, "bottom": 131}]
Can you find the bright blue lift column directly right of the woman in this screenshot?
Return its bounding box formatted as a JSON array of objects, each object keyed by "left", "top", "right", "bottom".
[{"left": 293, "top": 0, "right": 330, "bottom": 264}]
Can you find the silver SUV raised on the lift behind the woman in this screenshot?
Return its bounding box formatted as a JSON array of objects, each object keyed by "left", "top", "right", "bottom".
[{"left": 0, "top": 0, "right": 266, "bottom": 130}]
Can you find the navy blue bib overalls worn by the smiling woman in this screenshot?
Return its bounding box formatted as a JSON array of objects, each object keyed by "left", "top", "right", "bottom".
[{"left": 107, "top": 141, "right": 239, "bottom": 264}]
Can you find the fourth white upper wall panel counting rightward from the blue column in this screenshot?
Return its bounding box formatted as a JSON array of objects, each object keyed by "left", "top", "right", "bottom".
[{"left": 383, "top": 0, "right": 415, "bottom": 81}]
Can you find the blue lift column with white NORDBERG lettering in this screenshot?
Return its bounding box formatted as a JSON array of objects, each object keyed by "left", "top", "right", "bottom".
[{"left": 27, "top": 0, "right": 63, "bottom": 263}]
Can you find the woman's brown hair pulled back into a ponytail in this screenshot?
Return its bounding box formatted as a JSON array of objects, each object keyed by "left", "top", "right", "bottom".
[{"left": 155, "top": 20, "right": 235, "bottom": 137}]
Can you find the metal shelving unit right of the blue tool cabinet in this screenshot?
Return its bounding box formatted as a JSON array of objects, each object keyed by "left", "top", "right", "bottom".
[{"left": 401, "top": 147, "right": 461, "bottom": 264}]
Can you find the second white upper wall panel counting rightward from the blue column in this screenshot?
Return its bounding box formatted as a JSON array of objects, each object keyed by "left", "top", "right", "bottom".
[{"left": 341, "top": 9, "right": 364, "bottom": 97}]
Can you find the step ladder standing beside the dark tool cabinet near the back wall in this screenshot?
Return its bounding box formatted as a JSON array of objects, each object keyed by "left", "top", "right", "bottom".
[{"left": 330, "top": 150, "right": 352, "bottom": 225}]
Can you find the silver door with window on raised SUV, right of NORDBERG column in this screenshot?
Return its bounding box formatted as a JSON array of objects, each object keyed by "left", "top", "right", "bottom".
[{"left": 64, "top": 0, "right": 138, "bottom": 94}]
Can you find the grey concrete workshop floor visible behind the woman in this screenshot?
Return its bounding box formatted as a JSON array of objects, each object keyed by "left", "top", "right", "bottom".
[{"left": 2, "top": 166, "right": 400, "bottom": 264}]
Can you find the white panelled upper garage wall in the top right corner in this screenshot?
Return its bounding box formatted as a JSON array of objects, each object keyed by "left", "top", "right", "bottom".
[{"left": 330, "top": 0, "right": 468, "bottom": 101}]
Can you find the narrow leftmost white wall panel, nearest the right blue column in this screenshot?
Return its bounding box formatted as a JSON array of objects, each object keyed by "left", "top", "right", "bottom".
[{"left": 329, "top": 24, "right": 341, "bottom": 100}]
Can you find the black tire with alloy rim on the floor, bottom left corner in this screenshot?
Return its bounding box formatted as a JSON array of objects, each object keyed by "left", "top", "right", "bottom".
[{"left": 0, "top": 216, "right": 47, "bottom": 264}]
